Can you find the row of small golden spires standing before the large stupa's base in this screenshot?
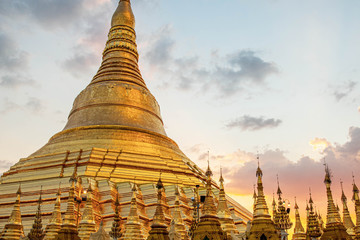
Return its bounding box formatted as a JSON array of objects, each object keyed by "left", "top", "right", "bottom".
[{"left": 0, "top": 162, "right": 239, "bottom": 240}]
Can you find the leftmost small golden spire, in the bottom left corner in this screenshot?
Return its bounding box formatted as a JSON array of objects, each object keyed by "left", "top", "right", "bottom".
[{"left": 0, "top": 185, "right": 24, "bottom": 240}]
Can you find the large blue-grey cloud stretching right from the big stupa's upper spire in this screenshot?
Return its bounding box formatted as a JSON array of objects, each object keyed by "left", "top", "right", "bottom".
[{"left": 141, "top": 29, "right": 279, "bottom": 97}]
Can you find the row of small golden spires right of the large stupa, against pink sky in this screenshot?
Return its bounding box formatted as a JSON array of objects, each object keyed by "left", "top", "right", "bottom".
[{"left": 250, "top": 159, "right": 360, "bottom": 240}]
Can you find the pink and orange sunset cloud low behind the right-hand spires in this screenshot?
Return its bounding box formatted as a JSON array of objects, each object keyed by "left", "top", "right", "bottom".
[{"left": 193, "top": 127, "right": 360, "bottom": 218}]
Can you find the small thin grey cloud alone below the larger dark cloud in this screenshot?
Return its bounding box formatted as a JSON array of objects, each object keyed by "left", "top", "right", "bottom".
[{"left": 226, "top": 115, "right": 282, "bottom": 131}]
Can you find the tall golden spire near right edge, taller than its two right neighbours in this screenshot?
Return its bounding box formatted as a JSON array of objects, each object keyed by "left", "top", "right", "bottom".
[{"left": 320, "top": 165, "right": 352, "bottom": 240}]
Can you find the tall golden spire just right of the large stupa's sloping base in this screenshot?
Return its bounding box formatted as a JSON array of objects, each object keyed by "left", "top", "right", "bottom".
[{"left": 247, "top": 157, "right": 280, "bottom": 240}]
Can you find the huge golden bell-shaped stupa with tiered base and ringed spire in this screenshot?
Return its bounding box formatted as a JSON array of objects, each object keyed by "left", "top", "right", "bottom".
[{"left": 0, "top": 0, "right": 252, "bottom": 236}]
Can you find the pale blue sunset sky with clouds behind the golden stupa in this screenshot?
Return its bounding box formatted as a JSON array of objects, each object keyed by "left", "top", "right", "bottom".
[{"left": 0, "top": 0, "right": 360, "bottom": 232}]
